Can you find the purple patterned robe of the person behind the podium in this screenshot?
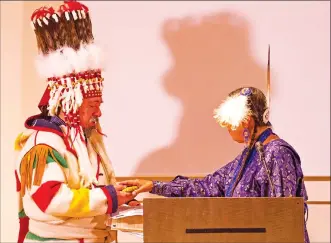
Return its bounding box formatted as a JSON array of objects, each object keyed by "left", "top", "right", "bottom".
[{"left": 151, "top": 139, "right": 309, "bottom": 243}]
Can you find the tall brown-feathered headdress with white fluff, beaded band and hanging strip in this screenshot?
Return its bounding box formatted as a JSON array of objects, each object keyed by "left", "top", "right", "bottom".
[{"left": 31, "top": 1, "right": 103, "bottom": 185}]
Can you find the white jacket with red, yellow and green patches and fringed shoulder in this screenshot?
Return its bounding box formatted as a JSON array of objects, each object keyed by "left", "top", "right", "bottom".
[{"left": 15, "top": 116, "right": 118, "bottom": 243}]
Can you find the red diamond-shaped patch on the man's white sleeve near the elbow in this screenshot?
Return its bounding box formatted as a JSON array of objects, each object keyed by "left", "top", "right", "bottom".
[{"left": 32, "top": 181, "right": 62, "bottom": 212}]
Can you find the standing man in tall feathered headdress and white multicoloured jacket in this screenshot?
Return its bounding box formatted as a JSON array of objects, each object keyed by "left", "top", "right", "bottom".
[{"left": 15, "top": 1, "right": 133, "bottom": 243}]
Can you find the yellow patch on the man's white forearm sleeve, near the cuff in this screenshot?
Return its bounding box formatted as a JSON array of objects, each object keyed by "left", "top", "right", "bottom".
[{"left": 68, "top": 188, "right": 90, "bottom": 217}]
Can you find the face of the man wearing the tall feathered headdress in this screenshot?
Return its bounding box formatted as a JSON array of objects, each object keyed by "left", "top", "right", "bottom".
[{"left": 79, "top": 97, "right": 103, "bottom": 129}]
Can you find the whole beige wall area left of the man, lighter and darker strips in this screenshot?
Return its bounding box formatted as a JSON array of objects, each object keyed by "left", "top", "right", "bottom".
[{"left": 1, "top": 1, "right": 59, "bottom": 242}]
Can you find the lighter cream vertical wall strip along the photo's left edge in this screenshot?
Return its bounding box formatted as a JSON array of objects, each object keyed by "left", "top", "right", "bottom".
[{"left": 1, "top": 1, "right": 23, "bottom": 242}]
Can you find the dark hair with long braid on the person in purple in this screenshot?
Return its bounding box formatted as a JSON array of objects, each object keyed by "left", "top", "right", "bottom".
[{"left": 229, "top": 87, "right": 271, "bottom": 195}]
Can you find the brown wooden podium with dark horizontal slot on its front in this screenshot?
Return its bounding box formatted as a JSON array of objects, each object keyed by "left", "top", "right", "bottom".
[{"left": 143, "top": 197, "right": 304, "bottom": 243}]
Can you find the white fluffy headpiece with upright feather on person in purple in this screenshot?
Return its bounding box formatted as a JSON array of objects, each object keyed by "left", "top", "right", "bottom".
[{"left": 214, "top": 46, "right": 270, "bottom": 130}]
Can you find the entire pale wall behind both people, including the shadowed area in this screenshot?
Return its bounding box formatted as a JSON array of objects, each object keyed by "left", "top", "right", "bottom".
[{"left": 1, "top": 1, "right": 330, "bottom": 242}]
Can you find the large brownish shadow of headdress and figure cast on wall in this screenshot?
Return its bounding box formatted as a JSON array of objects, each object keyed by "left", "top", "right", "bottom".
[{"left": 134, "top": 13, "right": 267, "bottom": 176}]
